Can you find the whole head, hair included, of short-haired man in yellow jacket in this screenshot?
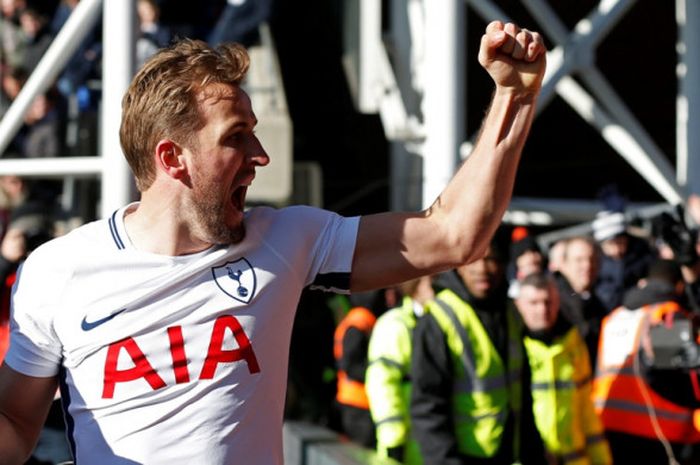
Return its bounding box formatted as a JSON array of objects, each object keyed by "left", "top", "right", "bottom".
[{"left": 515, "top": 272, "right": 559, "bottom": 332}]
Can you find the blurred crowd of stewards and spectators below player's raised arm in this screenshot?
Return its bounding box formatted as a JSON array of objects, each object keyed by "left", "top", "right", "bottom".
[{"left": 287, "top": 196, "right": 700, "bottom": 465}]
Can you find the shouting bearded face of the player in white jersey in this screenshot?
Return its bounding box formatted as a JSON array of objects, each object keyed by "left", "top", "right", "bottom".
[{"left": 183, "top": 84, "right": 270, "bottom": 244}]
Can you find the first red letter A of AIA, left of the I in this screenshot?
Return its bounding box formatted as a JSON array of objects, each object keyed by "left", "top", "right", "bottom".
[{"left": 102, "top": 337, "right": 165, "bottom": 399}]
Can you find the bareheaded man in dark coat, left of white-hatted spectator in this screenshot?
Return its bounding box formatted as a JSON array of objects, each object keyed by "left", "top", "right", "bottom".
[{"left": 554, "top": 236, "right": 608, "bottom": 368}]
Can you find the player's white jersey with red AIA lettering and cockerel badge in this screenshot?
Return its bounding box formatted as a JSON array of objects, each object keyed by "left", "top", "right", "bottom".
[{"left": 5, "top": 207, "right": 359, "bottom": 465}]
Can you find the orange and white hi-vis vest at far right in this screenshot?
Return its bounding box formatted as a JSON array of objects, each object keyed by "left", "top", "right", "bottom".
[{"left": 593, "top": 302, "right": 700, "bottom": 444}]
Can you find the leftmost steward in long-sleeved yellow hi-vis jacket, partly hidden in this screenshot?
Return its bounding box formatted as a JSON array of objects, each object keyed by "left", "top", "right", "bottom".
[{"left": 365, "top": 276, "right": 434, "bottom": 465}]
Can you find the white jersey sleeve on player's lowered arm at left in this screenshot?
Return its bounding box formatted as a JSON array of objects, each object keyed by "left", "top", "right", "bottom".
[{"left": 5, "top": 245, "right": 65, "bottom": 377}]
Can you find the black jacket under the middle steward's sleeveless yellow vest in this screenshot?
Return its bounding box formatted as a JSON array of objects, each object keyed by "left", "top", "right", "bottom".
[{"left": 411, "top": 271, "right": 546, "bottom": 465}]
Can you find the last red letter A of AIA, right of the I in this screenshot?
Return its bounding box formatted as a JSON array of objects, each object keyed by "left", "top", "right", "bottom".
[{"left": 199, "top": 315, "right": 260, "bottom": 379}]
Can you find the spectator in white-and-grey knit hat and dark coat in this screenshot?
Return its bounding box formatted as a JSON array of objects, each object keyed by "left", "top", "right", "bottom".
[{"left": 592, "top": 211, "right": 653, "bottom": 312}]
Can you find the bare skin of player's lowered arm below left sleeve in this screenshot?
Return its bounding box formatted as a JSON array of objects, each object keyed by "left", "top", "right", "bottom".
[{"left": 0, "top": 364, "right": 57, "bottom": 464}]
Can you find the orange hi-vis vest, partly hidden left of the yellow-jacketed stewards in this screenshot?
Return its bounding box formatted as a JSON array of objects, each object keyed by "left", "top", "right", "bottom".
[{"left": 333, "top": 307, "right": 377, "bottom": 410}]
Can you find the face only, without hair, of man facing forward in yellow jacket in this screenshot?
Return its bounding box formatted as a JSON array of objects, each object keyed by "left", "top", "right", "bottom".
[{"left": 515, "top": 283, "right": 559, "bottom": 331}]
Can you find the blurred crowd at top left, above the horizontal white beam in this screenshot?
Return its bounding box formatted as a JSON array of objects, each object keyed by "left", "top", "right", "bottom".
[{"left": 0, "top": 0, "right": 271, "bottom": 163}]
